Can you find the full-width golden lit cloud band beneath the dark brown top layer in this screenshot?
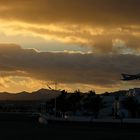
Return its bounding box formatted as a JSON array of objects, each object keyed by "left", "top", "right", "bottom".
[{"left": 0, "top": 20, "right": 140, "bottom": 55}]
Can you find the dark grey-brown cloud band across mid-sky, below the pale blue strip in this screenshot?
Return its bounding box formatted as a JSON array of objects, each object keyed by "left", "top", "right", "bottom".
[{"left": 0, "top": 44, "right": 140, "bottom": 87}]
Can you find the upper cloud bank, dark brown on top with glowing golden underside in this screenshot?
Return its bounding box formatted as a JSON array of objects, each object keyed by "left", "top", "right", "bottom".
[{"left": 0, "top": 0, "right": 140, "bottom": 54}]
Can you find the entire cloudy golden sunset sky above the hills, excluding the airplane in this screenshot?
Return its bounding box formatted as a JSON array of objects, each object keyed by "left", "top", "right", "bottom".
[{"left": 0, "top": 0, "right": 140, "bottom": 93}]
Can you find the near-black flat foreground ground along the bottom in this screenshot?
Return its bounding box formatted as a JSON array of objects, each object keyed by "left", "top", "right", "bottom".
[{"left": 0, "top": 119, "right": 140, "bottom": 140}]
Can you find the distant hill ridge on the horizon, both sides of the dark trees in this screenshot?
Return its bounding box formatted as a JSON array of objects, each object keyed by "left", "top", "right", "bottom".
[{"left": 0, "top": 88, "right": 128, "bottom": 101}]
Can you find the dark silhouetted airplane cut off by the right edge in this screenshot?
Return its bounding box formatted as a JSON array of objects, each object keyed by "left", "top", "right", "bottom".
[{"left": 121, "top": 73, "right": 140, "bottom": 81}]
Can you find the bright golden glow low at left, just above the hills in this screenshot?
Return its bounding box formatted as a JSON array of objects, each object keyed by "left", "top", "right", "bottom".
[{"left": 0, "top": 76, "right": 46, "bottom": 93}]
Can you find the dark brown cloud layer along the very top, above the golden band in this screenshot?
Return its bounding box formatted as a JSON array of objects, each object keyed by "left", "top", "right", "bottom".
[{"left": 0, "top": 0, "right": 140, "bottom": 26}]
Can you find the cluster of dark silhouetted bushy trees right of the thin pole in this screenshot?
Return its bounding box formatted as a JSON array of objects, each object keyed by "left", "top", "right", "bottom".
[{"left": 48, "top": 90, "right": 105, "bottom": 118}]
